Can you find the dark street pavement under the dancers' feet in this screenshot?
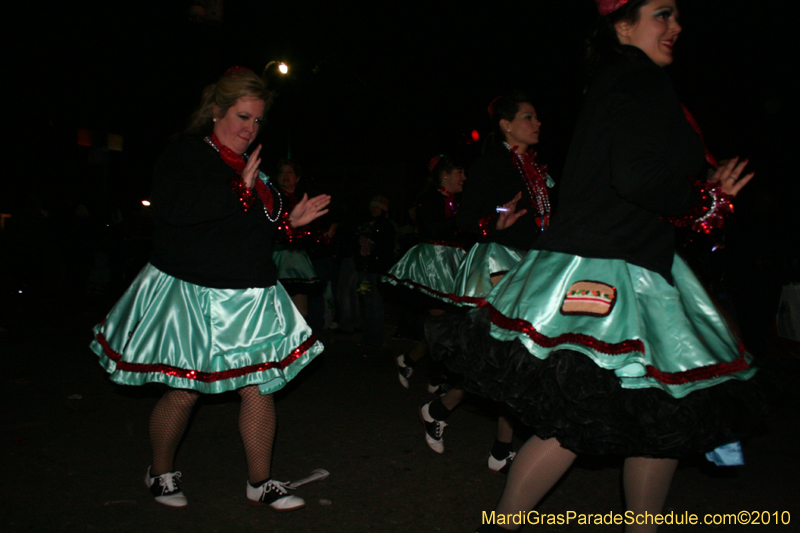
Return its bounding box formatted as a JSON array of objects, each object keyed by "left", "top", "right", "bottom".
[{"left": 0, "top": 299, "right": 800, "bottom": 533}]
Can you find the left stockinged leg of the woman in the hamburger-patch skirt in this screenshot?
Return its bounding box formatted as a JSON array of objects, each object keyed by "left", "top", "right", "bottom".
[{"left": 497, "top": 437, "right": 576, "bottom": 530}]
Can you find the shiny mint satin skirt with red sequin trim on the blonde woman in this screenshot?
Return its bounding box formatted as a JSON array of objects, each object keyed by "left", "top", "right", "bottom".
[{"left": 91, "top": 264, "right": 323, "bottom": 394}]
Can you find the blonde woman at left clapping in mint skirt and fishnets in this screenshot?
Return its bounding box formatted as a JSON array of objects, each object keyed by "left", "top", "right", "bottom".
[{"left": 92, "top": 67, "right": 330, "bottom": 511}]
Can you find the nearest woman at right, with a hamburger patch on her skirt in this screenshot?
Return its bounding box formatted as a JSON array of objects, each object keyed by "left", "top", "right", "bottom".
[{"left": 450, "top": 0, "right": 764, "bottom": 532}]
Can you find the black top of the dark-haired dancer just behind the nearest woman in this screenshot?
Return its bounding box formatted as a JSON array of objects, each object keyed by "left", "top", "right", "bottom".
[{"left": 458, "top": 145, "right": 542, "bottom": 250}]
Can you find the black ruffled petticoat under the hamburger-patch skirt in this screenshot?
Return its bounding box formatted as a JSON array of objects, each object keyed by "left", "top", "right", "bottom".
[{"left": 426, "top": 309, "right": 769, "bottom": 458}]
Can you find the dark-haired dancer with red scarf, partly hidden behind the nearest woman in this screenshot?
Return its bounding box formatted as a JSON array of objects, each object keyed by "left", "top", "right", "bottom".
[{"left": 421, "top": 93, "right": 553, "bottom": 472}]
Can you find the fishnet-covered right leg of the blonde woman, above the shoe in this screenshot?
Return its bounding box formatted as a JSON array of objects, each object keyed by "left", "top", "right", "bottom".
[{"left": 238, "top": 385, "right": 278, "bottom": 486}]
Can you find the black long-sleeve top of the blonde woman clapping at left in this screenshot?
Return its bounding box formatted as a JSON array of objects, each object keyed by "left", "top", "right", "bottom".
[{"left": 150, "top": 137, "right": 277, "bottom": 289}]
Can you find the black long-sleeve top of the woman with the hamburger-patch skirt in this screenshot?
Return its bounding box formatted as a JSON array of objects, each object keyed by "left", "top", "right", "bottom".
[{"left": 535, "top": 47, "right": 704, "bottom": 282}]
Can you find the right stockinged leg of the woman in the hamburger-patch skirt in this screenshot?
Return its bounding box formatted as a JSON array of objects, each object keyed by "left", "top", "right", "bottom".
[{"left": 622, "top": 457, "right": 678, "bottom": 533}]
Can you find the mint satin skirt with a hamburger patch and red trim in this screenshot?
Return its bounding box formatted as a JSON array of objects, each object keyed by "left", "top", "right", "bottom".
[{"left": 486, "top": 250, "right": 755, "bottom": 398}]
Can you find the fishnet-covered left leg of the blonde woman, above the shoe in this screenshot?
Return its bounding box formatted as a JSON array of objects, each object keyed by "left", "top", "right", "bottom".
[{"left": 150, "top": 389, "right": 200, "bottom": 476}]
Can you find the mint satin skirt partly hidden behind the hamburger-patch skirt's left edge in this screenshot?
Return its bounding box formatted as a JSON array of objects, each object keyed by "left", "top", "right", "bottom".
[{"left": 453, "top": 242, "right": 525, "bottom": 306}]
